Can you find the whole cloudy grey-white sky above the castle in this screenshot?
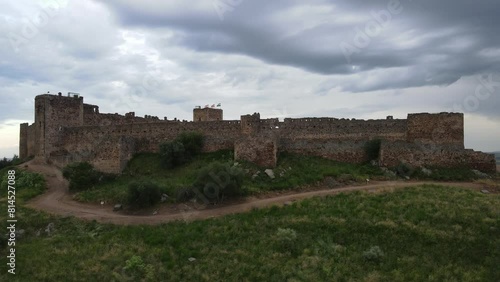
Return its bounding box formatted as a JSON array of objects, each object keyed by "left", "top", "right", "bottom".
[{"left": 0, "top": 0, "right": 500, "bottom": 157}]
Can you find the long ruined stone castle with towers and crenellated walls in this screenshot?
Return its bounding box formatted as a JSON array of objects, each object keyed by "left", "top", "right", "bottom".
[{"left": 19, "top": 93, "right": 496, "bottom": 173}]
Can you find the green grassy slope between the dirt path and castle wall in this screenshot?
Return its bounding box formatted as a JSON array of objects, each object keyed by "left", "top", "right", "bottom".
[{"left": 75, "top": 151, "right": 383, "bottom": 203}]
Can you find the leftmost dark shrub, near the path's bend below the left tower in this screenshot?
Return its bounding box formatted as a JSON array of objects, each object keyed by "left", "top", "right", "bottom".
[{"left": 63, "top": 162, "right": 103, "bottom": 191}]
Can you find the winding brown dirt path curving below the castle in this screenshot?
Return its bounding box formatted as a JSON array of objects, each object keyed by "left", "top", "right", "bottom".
[{"left": 27, "top": 162, "right": 480, "bottom": 224}]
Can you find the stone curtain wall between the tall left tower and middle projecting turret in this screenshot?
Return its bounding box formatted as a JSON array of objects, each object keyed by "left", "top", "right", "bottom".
[{"left": 58, "top": 121, "right": 240, "bottom": 173}]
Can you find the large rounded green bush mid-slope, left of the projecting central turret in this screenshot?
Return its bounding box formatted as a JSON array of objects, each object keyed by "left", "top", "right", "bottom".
[{"left": 193, "top": 162, "right": 244, "bottom": 203}]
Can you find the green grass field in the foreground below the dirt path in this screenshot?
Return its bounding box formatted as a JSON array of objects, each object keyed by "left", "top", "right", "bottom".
[{"left": 0, "top": 186, "right": 500, "bottom": 281}]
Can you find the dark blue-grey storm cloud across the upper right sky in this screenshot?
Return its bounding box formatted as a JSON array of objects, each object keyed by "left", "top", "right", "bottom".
[{"left": 100, "top": 0, "right": 500, "bottom": 92}]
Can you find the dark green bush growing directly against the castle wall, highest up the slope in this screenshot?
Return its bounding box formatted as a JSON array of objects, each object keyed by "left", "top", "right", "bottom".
[{"left": 160, "top": 132, "right": 203, "bottom": 168}]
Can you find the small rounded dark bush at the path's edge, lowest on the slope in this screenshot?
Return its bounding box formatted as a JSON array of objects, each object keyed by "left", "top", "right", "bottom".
[{"left": 127, "top": 181, "right": 161, "bottom": 208}]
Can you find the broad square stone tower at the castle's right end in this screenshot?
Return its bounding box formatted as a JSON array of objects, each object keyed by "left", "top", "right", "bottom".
[{"left": 407, "top": 113, "right": 464, "bottom": 149}]
